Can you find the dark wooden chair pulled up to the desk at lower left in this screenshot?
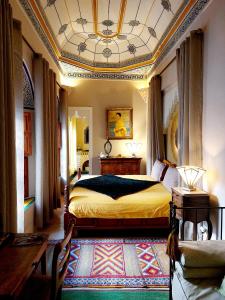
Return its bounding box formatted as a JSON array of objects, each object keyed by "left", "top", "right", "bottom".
[{"left": 19, "top": 223, "right": 74, "bottom": 300}]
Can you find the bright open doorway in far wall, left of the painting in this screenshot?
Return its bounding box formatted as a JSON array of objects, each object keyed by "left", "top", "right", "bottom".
[{"left": 68, "top": 107, "right": 93, "bottom": 179}]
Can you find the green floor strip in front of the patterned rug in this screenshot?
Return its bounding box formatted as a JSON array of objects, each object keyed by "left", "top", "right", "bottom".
[{"left": 62, "top": 290, "right": 169, "bottom": 300}]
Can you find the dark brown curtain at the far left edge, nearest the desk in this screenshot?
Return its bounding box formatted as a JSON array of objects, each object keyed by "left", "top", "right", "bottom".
[{"left": 0, "top": 0, "right": 17, "bottom": 232}]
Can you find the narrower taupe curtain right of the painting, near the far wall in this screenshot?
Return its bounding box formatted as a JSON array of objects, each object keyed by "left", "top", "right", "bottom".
[{"left": 149, "top": 75, "right": 165, "bottom": 170}]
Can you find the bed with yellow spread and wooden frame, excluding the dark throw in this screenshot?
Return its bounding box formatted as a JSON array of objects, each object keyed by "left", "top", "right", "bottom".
[{"left": 64, "top": 175, "right": 171, "bottom": 236}]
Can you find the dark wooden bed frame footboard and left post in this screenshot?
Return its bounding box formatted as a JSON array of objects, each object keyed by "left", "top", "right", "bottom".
[{"left": 64, "top": 185, "right": 169, "bottom": 236}]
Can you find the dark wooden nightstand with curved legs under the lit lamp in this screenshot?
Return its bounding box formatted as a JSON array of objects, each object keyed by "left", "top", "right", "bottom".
[{"left": 172, "top": 187, "right": 212, "bottom": 240}]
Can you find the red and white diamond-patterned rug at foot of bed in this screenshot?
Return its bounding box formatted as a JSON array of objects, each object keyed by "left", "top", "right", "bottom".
[{"left": 64, "top": 238, "right": 169, "bottom": 289}]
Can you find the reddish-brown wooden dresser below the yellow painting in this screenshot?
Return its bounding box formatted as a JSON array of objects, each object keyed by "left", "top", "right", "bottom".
[{"left": 100, "top": 157, "right": 141, "bottom": 175}]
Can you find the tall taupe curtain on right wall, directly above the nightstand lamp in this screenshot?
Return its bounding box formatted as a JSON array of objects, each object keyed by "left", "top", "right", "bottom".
[{"left": 176, "top": 29, "right": 203, "bottom": 166}]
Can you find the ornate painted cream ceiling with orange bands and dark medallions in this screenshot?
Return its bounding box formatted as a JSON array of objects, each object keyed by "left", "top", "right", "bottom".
[{"left": 20, "top": 0, "right": 210, "bottom": 79}]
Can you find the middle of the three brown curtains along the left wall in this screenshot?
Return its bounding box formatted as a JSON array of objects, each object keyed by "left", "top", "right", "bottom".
[{"left": 34, "top": 54, "right": 59, "bottom": 228}]
